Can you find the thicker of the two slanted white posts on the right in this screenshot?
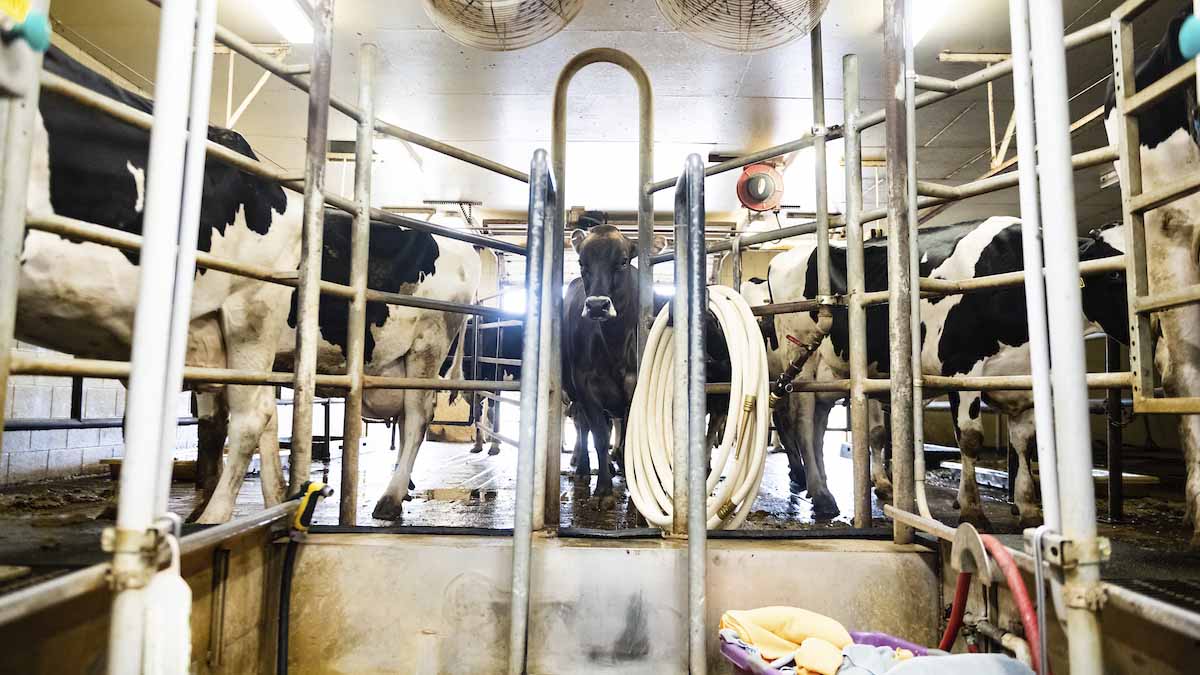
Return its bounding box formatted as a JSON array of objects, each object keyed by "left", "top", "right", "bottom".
[{"left": 1028, "top": 2, "right": 1104, "bottom": 675}]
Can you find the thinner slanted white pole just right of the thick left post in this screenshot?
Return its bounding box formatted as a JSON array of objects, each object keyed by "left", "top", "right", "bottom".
[{"left": 155, "top": 0, "right": 217, "bottom": 506}]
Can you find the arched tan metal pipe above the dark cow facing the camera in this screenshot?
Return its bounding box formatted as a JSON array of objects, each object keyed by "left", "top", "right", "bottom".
[{"left": 550, "top": 47, "right": 657, "bottom": 363}]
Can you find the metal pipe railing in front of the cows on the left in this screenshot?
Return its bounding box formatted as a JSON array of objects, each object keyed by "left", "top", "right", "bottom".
[{"left": 0, "top": 0, "right": 540, "bottom": 634}]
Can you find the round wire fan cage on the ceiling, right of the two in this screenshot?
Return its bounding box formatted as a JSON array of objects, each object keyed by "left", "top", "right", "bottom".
[{"left": 656, "top": 0, "right": 829, "bottom": 53}]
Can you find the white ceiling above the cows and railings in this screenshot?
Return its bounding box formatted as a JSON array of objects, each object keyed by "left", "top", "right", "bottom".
[{"left": 52, "top": 0, "right": 1177, "bottom": 228}]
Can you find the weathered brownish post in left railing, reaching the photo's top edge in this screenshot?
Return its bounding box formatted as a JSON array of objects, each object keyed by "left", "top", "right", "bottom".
[{"left": 288, "top": 0, "right": 334, "bottom": 491}]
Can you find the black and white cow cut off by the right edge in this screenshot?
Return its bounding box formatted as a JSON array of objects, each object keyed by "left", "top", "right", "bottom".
[{"left": 1105, "top": 10, "right": 1200, "bottom": 540}]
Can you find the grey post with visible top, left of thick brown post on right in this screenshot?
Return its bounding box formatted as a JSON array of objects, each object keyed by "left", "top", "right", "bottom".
[{"left": 841, "top": 54, "right": 871, "bottom": 527}]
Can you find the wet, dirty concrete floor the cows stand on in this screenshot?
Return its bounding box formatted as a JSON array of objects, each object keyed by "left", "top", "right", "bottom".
[{"left": 0, "top": 413, "right": 1200, "bottom": 578}]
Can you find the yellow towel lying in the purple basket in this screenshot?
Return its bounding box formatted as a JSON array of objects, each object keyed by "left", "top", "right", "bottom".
[{"left": 721, "top": 607, "right": 852, "bottom": 662}]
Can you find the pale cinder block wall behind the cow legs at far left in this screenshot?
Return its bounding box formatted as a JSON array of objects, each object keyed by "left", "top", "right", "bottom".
[{"left": 0, "top": 342, "right": 196, "bottom": 484}]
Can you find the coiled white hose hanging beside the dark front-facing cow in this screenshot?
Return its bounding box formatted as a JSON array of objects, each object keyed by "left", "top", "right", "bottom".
[{"left": 625, "top": 286, "right": 770, "bottom": 530}]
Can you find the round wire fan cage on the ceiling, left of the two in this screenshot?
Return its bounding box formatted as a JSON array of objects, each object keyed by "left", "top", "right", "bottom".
[{"left": 425, "top": 0, "right": 583, "bottom": 52}]
